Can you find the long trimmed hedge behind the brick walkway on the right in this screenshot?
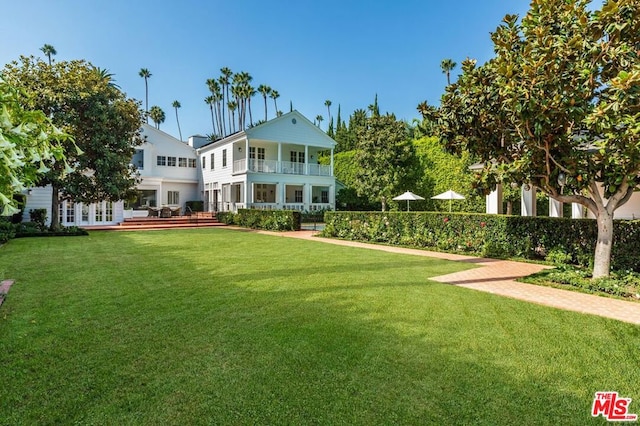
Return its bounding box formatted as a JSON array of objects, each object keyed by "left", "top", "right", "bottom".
[{"left": 323, "top": 212, "right": 640, "bottom": 272}]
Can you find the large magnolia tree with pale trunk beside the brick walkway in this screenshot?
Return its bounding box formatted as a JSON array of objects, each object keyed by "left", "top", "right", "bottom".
[{"left": 440, "top": 0, "right": 640, "bottom": 278}]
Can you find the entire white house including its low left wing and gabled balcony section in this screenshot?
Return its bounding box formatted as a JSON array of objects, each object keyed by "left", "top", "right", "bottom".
[{"left": 24, "top": 111, "right": 336, "bottom": 226}]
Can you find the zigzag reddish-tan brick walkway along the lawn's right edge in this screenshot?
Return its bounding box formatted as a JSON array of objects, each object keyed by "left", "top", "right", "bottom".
[{"left": 259, "top": 231, "right": 640, "bottom": 325}]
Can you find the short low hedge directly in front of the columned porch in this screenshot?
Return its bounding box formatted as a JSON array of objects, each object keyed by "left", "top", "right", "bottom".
[{"left": 217, "top": 209, "right": 302, "bottom": 231}]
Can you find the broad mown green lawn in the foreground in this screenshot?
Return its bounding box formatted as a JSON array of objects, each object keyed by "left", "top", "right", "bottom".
[{"left": 0, "top": 229, "right": 640, "bottom": 425}]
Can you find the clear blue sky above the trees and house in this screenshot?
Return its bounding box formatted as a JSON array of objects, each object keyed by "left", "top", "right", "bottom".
[{"left": 0, "top": 0, "right": 529, "bottom": 139}]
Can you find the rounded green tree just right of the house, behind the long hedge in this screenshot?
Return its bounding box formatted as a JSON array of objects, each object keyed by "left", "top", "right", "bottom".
[{"left": 354, "top": 114, "right": 419, "bottom": 211}]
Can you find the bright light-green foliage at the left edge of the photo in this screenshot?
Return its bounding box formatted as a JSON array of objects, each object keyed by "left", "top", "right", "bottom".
[{"left": 0, "top": 79, "right": 70, "bottom": 216}]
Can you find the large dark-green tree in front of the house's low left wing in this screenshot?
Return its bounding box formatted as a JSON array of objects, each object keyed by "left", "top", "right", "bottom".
[{"left": 3, "top": 57, "right": 141, "bottom": 227}]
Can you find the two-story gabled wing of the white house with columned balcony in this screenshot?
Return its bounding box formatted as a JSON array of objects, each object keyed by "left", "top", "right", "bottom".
[{"left": 197, "top": 111, "right": 336, "bottom": 211}]
